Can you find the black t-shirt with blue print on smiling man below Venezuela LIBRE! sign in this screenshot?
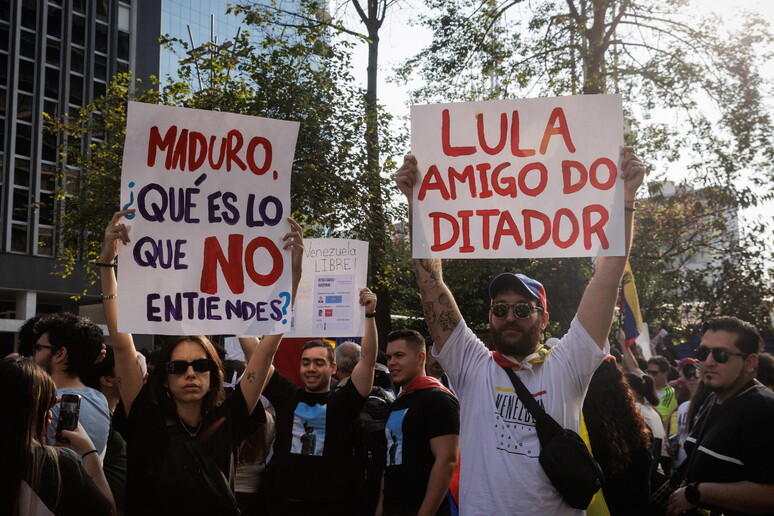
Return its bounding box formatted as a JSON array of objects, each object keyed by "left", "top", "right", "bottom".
[{"left": 263, "top": 371, "right": 365, "bottom": 501}]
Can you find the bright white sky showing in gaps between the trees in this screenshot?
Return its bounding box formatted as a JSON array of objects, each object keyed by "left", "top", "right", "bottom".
[{"left": 347, "top": 0, "right": 774, "bottom": 236}]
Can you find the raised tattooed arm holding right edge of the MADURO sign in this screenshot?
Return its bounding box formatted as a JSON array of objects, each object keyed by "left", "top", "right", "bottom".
[{"left": 239, "top": 218, "right": 304, "bottom": 414}]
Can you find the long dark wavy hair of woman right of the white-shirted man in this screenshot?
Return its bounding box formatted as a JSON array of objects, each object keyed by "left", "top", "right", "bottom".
[{"left": 583, "top": 357, "right": 650, "bottom": 477}]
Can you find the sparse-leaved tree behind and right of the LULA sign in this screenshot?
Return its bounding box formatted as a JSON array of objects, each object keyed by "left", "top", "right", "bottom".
[{"left": 399, "top": 0, "right": 774, "bottom": 334}]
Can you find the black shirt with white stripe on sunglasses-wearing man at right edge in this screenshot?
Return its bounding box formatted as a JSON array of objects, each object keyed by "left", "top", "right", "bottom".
[{"left": 685, "top": 385, "right": 774, "bottom": 515}]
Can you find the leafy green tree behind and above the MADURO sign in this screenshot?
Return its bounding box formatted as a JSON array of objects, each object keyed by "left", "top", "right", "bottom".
[{"left": 56, "top": 0, "right": 400, "bottom": 296}]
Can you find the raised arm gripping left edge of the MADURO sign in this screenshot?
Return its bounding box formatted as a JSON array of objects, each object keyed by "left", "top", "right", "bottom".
[{"left": 99, "top": 210, "right": 142, "bottom": 414}]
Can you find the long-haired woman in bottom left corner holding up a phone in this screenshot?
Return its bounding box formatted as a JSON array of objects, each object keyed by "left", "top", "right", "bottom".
[{"left": 0, "top": 357, "right": 114, "bottom": 516}]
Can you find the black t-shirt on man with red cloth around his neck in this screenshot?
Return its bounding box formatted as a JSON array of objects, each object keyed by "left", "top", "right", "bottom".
[{"left": 384, "top": 388, "right": 460, "bottom": 513}]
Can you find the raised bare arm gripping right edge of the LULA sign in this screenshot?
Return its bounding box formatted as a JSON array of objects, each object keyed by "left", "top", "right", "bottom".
[{"left": 578, "top": 147, "right": 646, "bottom": 348}]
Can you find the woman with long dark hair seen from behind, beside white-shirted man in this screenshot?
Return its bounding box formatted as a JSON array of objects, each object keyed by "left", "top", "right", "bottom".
[{"left": 583, "top": 355, "right": 651, "bottom": 516}]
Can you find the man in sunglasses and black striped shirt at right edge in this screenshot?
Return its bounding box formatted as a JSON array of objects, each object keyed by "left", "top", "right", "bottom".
[{"left": 667, "top": 317, "right": 774, "bottom": 516}]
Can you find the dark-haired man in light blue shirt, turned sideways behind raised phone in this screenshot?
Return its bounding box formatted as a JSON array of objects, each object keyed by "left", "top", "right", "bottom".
[{"left": 33, "top": 312, "right": 110, "bottom": 462}]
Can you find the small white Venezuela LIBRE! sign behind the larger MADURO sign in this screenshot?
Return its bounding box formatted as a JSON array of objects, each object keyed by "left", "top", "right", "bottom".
[{"left": 289, "top": 238, "right": 368, "bottom": 337}]
